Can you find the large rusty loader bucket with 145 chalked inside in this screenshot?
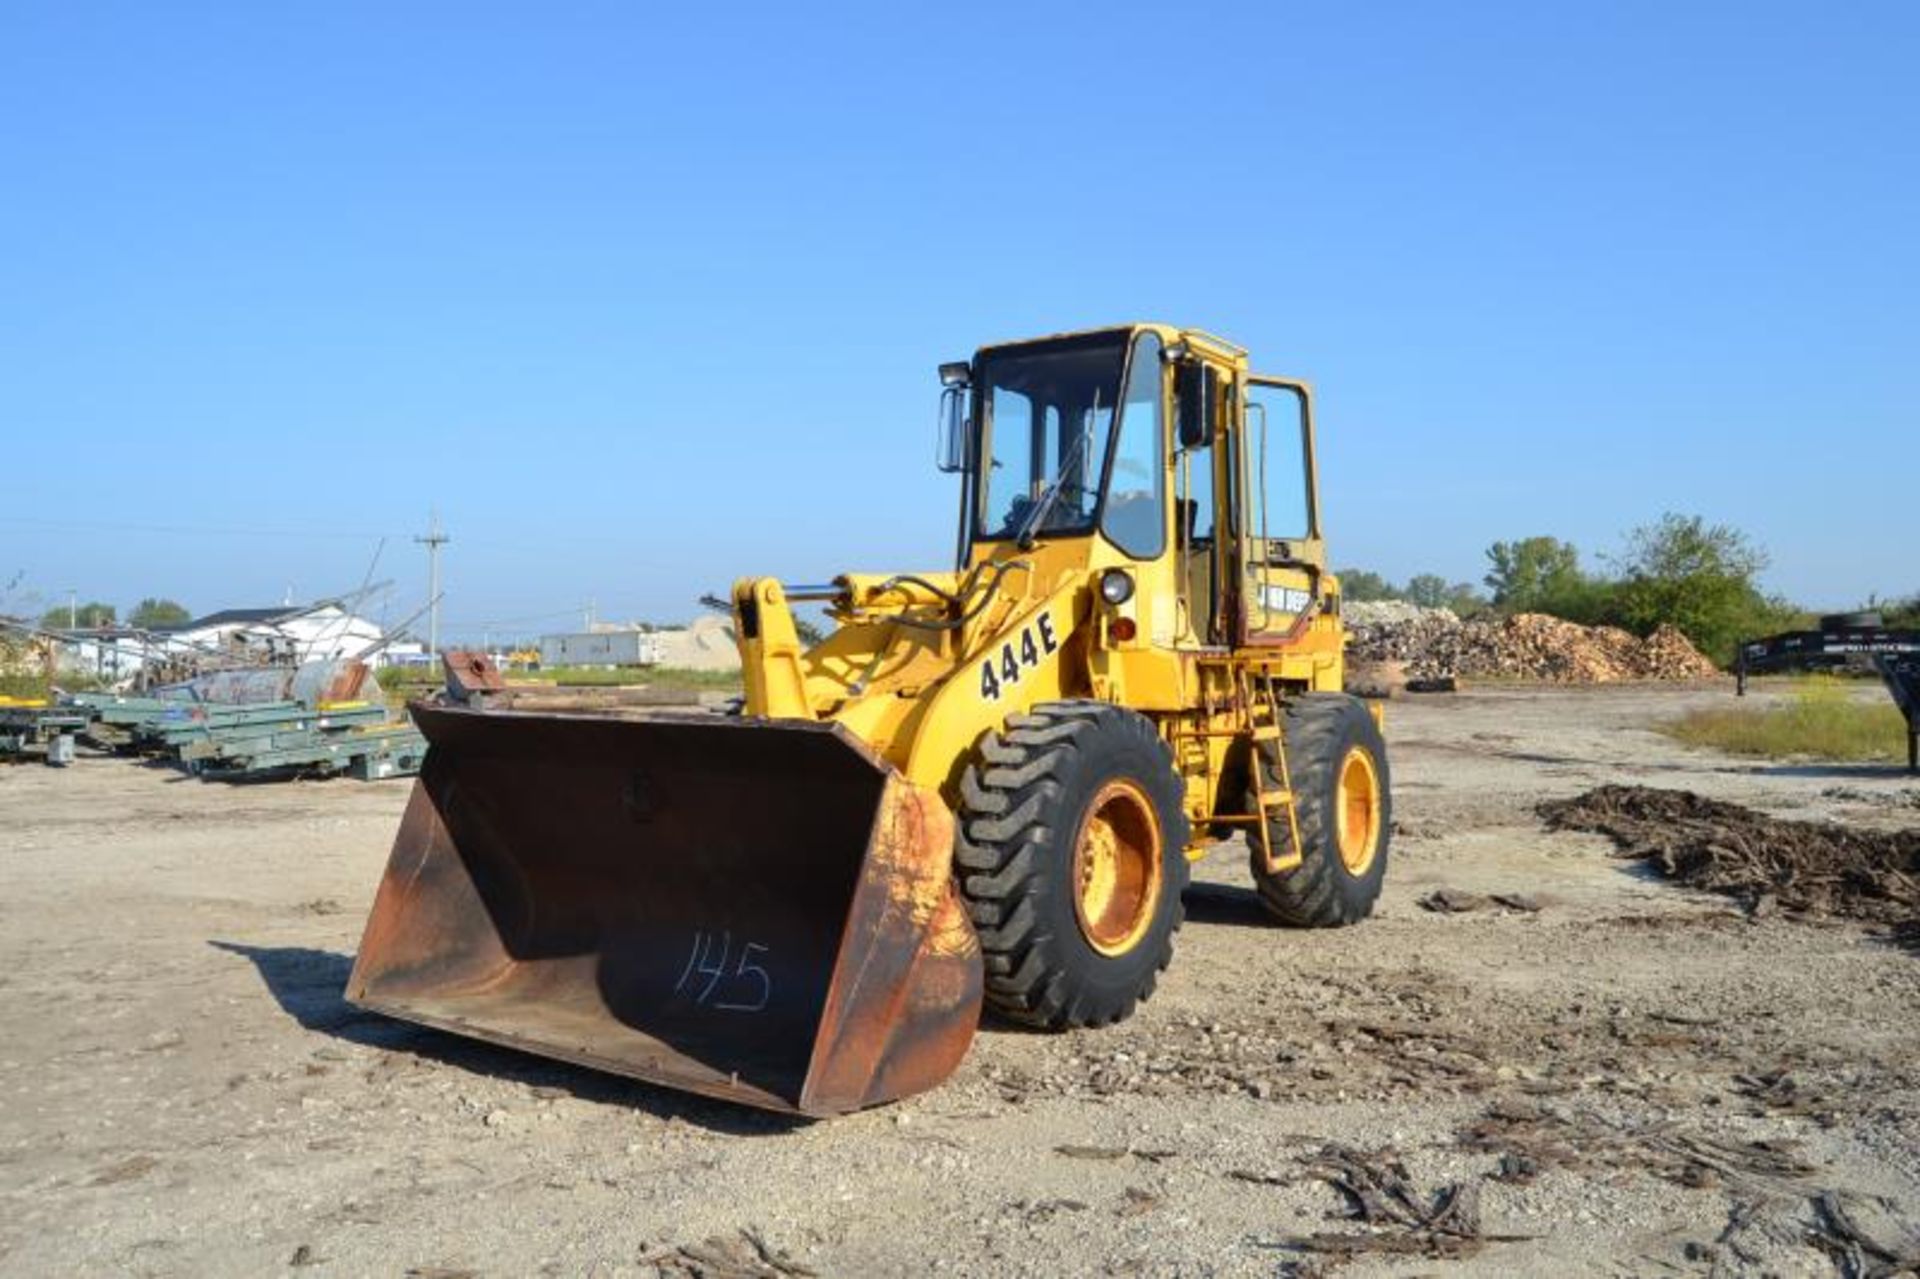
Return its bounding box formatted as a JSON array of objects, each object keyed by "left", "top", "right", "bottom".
[{"left": 348, "top": 705, "right": 983, "bottom": 1116}]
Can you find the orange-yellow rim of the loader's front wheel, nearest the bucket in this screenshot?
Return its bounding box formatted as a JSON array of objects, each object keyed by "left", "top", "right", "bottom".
[{"left": 1073, "top": 782, "right": 1160, "bottom": 956}]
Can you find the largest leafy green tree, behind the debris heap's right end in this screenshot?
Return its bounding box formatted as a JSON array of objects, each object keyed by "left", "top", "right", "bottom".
[{"left": 1613, "top": 513, "right": 1797, "bottom": 663}]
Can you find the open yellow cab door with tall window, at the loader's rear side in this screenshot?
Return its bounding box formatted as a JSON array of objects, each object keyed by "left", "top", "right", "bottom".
[{"left": 1235, "top": 376, "right": 1327, "bottom": 645}]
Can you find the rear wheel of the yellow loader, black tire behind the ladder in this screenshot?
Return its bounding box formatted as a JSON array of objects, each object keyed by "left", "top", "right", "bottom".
[{"left": 1246, "top": 693, "right": 1394, "bottom": 928}]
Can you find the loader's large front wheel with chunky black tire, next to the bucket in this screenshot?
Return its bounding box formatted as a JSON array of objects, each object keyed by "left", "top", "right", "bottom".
[{"left": 954, "top": 701, "right": 1188, "bottom": 1029}]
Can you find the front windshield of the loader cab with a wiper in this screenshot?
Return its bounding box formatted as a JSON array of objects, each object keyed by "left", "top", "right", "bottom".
[{"left": 975, "top": 332, "right": 1127, "bottom": 542}]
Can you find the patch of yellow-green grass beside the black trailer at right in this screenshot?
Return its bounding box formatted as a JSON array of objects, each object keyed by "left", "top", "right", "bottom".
[{"left": 1661, "top": 676, "right": 1907, "bottom": 762}]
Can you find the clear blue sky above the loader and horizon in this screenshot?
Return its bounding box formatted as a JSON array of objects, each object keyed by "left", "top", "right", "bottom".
[{"left": 0, "top": 2, "right": 1920, "bottom": 636}]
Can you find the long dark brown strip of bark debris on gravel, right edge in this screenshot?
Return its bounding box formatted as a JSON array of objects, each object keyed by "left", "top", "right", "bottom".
[{"left": 1538, "top": 785, "right": 1920, "bottom": 935}]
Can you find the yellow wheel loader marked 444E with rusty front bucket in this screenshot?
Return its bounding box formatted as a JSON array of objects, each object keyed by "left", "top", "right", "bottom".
[{"left": 348, "top": 325, "right": 1390, "bottom": 1116}]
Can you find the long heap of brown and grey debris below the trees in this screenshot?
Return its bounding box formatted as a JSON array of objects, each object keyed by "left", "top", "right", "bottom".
[{"left": 1344, "top": 601, "right": 1716, "bottom": 684}]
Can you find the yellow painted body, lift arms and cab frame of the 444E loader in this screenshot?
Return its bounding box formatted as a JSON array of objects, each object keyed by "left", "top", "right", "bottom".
[{"left": 732, "top": 325, "right": 1346, "bottom": 870}]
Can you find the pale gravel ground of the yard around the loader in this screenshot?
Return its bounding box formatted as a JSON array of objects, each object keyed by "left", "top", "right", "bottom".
[{"left": 0, "top": 686, "right": 1920, "bottom": 1279}]
